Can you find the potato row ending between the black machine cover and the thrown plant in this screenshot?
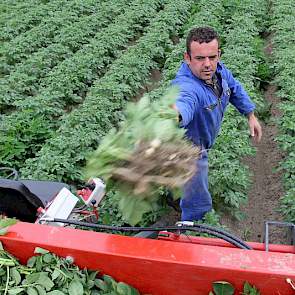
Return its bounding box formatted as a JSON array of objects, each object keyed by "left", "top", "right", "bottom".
[{"left": 21, "top": 0, "right": 193, "bottom": 185}]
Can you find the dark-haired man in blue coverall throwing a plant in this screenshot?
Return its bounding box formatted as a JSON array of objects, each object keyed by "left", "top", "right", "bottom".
[{"left": 172, "top": 27, "right": 262, "bottom": 220}]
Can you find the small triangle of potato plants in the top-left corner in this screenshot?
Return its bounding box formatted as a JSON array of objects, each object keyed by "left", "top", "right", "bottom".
[{"left": 0, "top": 0, "right": 71, "bottom": 42}]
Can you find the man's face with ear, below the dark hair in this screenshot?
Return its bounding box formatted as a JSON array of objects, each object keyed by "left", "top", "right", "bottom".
[{"left": 184, "top": 39, "right": 220, "bottom": 82}]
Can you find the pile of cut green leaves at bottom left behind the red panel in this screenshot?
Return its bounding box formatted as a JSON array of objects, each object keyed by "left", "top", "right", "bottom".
[{"left": 0, "top": 243, "right": 139, "bottom": 295}]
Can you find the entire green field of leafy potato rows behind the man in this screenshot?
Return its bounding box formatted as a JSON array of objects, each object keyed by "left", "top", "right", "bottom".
[{"left": 0, "top": 0, "right": 295, "bottom": 230}]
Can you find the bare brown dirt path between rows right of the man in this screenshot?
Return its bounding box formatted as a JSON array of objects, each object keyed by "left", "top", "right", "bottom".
[{"left": 222, "top": 85, "right": 286, "bottom": 243}]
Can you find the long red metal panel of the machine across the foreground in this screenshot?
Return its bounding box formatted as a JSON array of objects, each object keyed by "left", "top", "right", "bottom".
[{"left": 0, "top": 222, "right": 295, "bottom": 295}]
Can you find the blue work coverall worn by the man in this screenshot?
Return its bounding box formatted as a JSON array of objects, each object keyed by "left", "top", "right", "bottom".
[{"left": 172, "top": 62, "right": 255, "bottom": 220}]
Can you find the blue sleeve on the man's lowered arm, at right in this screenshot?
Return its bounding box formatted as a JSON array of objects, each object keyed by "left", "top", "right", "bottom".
[{"left": 226, "top": 70, "right": 255, "bottom": 115}]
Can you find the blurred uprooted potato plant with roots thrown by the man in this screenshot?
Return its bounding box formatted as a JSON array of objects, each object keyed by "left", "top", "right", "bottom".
[{"left": 85, "top": 89, "right": 199, "bottom": 225}]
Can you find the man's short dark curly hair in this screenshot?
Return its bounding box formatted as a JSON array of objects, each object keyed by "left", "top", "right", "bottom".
[{"left": 186, "top": 27, "right": 219, "bottom": 56}]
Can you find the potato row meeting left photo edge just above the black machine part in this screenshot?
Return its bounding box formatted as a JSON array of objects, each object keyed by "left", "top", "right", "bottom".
[{"left": 0, "top": 0, "right": 163, "bottom": 171}]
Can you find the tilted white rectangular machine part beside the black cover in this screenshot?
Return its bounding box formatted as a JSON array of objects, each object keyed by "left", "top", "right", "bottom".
[{"left": 37, "top": 187, "right": 79, "bottom": 226}]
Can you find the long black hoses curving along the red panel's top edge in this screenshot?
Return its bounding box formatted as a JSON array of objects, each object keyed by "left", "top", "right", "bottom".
[{"left": 53, "top": 218, "right": 252, "bottom": 250}]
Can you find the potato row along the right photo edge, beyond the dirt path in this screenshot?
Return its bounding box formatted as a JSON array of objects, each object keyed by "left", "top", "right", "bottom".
[{"left": 271, "top": 0, "right": 295, "bottom": 223}]
